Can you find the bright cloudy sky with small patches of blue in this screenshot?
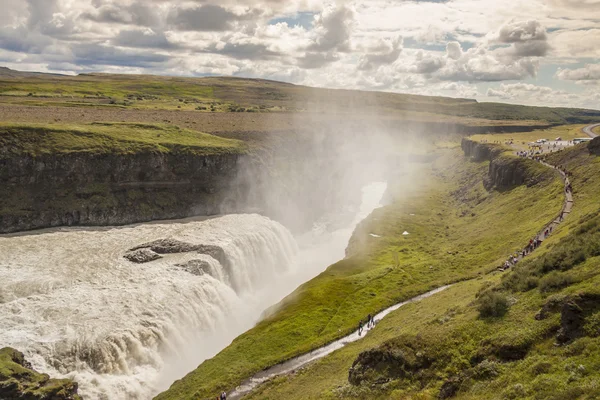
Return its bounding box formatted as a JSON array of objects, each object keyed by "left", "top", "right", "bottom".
[{"left": 0, "top": 0, "right": 600, "bottom": 109}]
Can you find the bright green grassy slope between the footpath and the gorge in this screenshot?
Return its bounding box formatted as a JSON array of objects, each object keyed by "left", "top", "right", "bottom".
[{"left": 157, "top": 144, "right": 562, "bottom": 399}]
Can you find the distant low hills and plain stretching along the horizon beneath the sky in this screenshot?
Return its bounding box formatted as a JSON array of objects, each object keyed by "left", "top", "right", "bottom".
[{"left": 0, "top": 71, "right": 600, "bottom": 125}]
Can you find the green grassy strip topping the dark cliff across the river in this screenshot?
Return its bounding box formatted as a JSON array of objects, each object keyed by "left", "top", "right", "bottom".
[{"left": 0, "top": 123, "right": 246, "bottom": 155}]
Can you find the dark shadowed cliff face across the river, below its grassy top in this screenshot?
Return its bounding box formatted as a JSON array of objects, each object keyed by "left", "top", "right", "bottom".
[{"left": 0, "top": 153, "right": 245, "bottom": 233}]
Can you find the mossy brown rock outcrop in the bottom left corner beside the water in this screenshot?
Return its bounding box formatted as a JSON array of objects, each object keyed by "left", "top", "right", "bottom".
[{"left": 0, "top": 347, "right": 81, "bottom": 400}]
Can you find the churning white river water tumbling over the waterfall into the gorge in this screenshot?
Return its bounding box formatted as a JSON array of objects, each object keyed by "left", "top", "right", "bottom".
[{"left": 0, "top": 184, "right": 386, "bottom": 400}]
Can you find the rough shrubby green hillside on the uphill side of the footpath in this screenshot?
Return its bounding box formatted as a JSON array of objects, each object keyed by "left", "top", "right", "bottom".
[{"left": 237, "top": 140, "right": 600, "bottom": 400}]
